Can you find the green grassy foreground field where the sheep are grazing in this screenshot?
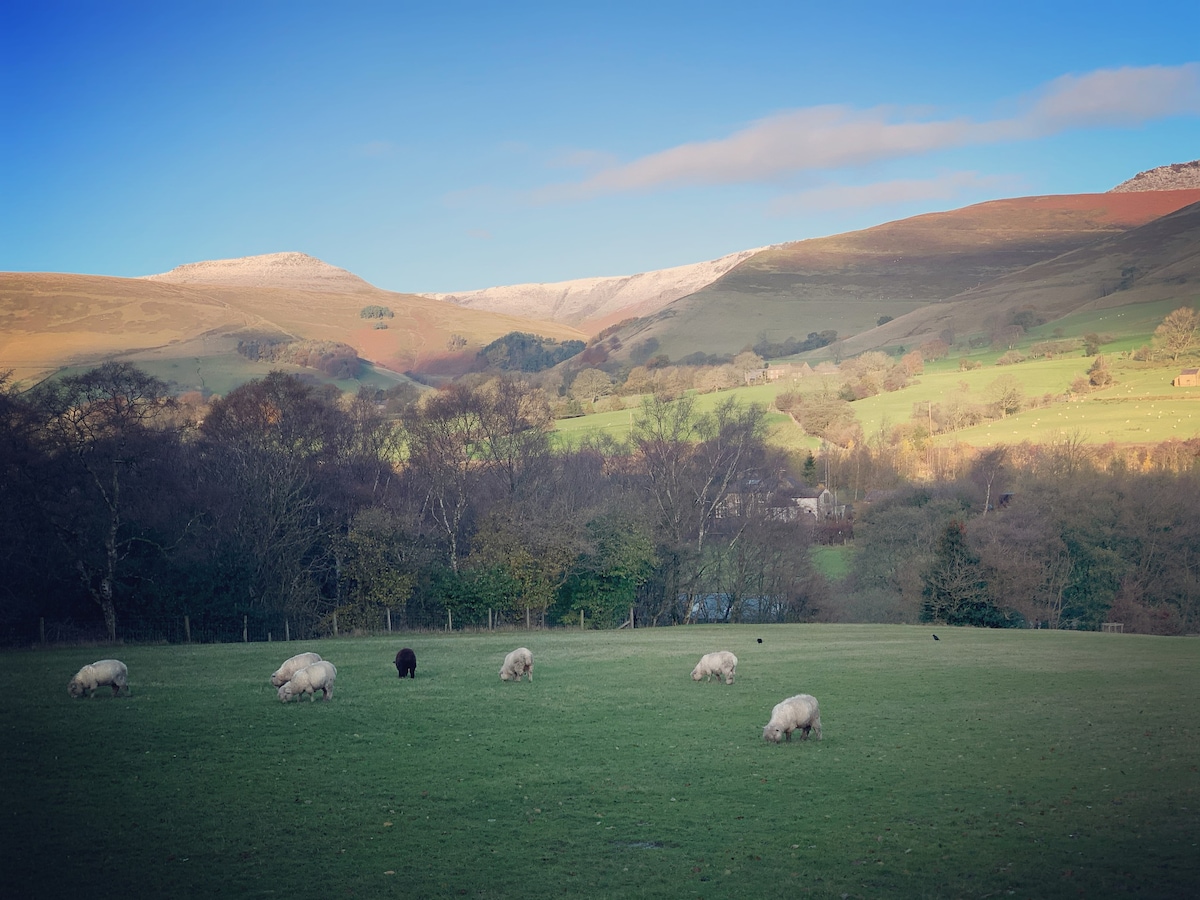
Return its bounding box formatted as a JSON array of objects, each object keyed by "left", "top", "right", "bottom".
[{"left": 0, "top": 625, "right": 1200, "bottom": 898}]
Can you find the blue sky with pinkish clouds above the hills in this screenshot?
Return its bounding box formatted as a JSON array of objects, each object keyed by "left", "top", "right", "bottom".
[{"left": 0, "top": 0, "right": 1200, "bottom": 292}]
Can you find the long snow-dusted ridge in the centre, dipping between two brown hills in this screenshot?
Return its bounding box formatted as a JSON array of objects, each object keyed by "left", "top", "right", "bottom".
[{"left": 422, "top": 250, "right": 760, "bottom": 325}]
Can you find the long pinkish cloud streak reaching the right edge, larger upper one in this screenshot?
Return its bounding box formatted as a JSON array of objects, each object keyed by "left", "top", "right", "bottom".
[{"left": 536, "top": 62, "right": 1200, "bottom": 200}]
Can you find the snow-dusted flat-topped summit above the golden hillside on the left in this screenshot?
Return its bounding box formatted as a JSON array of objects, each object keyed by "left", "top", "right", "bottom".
[{"left": 143, "top": 252, "right": 373, "bottom": 293}]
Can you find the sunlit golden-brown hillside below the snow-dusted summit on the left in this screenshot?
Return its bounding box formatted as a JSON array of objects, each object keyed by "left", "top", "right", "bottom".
[{"left": 0, "top": 264, "right": 583, "bottom": 380}]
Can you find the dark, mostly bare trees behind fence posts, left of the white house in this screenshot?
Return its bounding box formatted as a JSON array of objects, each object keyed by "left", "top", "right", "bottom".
[{"left": 0, "top": 362, "right": 821, "bottom": 641}]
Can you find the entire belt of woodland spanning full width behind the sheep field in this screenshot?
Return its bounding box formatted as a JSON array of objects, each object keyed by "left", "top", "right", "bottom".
[{"left": 0, "top": 362, "right": 1200, "bottom": 644}]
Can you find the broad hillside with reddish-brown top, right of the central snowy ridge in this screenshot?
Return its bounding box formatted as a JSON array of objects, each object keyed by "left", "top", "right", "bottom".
[{"left": 604, "top": 190, "right": 1200, "bottom": 359}]
